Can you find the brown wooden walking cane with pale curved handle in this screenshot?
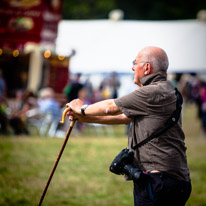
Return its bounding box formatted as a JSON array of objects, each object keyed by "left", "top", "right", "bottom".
[{"left": 38, "top": 107, "right": 75, "bottom": 206}]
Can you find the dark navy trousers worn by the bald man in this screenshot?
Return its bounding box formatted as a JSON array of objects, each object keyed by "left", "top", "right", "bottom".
[{"left": 134, "top": 173, "right": 191, "bottom": 206}]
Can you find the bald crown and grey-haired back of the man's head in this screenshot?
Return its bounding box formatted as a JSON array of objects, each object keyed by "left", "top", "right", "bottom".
[{"left": 138, "top": 46, "right": 169, "bottom": 72}]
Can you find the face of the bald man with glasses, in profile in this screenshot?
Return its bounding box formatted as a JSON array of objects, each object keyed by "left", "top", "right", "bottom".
[{"left": 132, "top": 56, "right": 147, "bottom": 87}]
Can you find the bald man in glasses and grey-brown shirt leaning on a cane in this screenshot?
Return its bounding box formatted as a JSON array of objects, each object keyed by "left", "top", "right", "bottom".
[{"left": 67, "top": 47, "right": 191, "bottom": 206}]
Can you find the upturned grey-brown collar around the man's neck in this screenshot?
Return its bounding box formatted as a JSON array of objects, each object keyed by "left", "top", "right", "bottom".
[{"left": 140, "top": 71, "right": 167, "bottom": 86}]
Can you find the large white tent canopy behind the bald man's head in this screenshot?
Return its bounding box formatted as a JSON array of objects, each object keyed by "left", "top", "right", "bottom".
[{"left": 56, "top": 20, "right": 206, "bottom": 73}]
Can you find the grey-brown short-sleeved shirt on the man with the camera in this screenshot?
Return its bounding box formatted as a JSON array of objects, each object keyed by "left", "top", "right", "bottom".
[{"left": 115, "top": 72, "right": 190, "bottom": 181}]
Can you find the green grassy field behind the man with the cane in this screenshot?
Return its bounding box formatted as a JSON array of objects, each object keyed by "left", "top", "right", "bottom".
[{"left": 0, "top": 105, "right": 206, "bottom": 206}]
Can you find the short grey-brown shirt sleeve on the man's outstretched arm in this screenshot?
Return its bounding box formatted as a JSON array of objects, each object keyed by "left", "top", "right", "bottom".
[{"left": 114, "top": 88, "right": 148, "bottom": 118}]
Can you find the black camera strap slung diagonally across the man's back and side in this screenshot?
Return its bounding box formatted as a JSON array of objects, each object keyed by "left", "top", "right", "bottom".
[{"left": 132, "top": 88, "right": 183, "bottom": 149}]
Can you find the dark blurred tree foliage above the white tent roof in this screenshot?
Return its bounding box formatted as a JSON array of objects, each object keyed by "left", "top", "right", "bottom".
[{"left": 63, "top": 0, "right": 206, "bottom": 20}]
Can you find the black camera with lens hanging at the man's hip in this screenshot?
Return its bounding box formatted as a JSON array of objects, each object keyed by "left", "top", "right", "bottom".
[{"left": 109, "top": 149, "right": 141, "bottom": 181}]
